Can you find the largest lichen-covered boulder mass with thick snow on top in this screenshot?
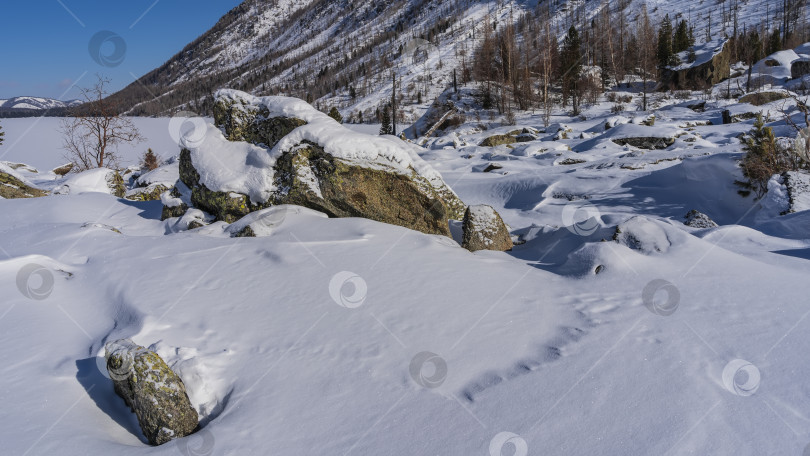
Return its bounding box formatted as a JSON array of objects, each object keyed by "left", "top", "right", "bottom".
[{"left": 170, "top": 90, "right": 465, "bottom": 235}]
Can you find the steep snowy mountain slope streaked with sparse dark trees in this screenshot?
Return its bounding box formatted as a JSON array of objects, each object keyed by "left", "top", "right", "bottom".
[{"left": 110, "top": 0, "right": 778, "bottom": 118}]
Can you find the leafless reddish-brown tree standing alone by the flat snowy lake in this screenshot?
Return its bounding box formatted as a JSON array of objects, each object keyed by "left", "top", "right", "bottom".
[{"left": 61, "top": 75, "right": 144, "bottom": 171}]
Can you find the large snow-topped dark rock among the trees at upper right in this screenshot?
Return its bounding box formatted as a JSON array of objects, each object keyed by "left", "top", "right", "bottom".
[{"left": 659, "top": 41, "right": 731, "bottom": 90}]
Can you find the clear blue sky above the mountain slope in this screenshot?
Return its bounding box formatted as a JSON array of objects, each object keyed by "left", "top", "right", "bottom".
[{"left": 0, "top": 0, "right": 241, "bottom": 100}]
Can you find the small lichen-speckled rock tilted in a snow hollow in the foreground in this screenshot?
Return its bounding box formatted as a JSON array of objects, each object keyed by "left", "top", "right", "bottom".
[{"left": 105, "top": 339, "right": 198, "bottom": 445}]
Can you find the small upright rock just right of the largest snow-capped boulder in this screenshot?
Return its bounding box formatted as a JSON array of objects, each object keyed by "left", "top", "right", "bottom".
[{"left": 461, "top": 204, "right": 512, "bottom": 252}]
